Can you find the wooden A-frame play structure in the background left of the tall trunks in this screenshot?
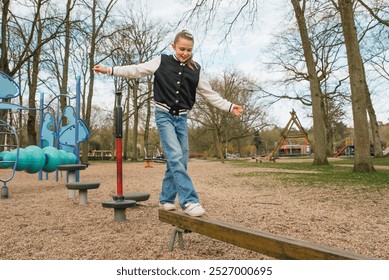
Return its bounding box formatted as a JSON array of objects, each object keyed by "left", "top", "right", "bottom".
[{"left": 264, "top": 110, "right": 313, "bottom": 161}]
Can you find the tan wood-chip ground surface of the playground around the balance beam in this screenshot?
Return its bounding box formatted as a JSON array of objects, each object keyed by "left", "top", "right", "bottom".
[{"left": 0, "top": 159, "right": 389, "bottom": 260}]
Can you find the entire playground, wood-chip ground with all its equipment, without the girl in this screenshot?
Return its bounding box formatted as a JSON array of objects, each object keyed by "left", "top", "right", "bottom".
[{"left": 0, "top": 71, "right": 389, "bottom": 260}]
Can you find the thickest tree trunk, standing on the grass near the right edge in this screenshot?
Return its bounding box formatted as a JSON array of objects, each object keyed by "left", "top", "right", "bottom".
[{"left": 338, "top": 0, "right": 374, "bottom": 172}]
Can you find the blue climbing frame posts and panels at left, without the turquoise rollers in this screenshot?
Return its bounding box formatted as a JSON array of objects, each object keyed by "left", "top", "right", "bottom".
[{"left": 0, "top": 71, "right": 90, "bottom": 196}]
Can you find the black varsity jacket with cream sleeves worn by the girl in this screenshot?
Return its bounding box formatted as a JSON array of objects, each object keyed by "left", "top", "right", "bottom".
[{"left": 111, "top": 55, "right": 234, "bottom": 115}]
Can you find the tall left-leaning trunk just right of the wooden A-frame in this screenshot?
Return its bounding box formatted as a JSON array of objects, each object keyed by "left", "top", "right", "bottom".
[{"left": 291, "top": 0, "right": 328, "bottom": 165}]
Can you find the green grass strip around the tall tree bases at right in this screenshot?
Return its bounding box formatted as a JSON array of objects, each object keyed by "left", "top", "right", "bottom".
[{"left": 229, "top": 157, "right": 389, "bottom": 188}]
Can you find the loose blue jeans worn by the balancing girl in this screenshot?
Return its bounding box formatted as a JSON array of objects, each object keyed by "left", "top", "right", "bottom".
[{"left": 155, "top": 108, "right": 199, "bottom": 209}]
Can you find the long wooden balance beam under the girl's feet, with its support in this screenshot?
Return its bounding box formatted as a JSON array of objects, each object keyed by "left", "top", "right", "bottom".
[{"left": 159, "top": 209, "right": 373, "bottom": 260}]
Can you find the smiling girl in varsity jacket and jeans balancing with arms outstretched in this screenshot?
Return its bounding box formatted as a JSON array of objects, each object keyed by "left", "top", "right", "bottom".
[{"left": 93, "top": 30, "right": 243, "bottom": 216}]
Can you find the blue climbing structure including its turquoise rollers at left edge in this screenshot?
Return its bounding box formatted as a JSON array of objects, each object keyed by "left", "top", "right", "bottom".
[{"left": 0, "top": 72, "right": 90, "bottom": 198}]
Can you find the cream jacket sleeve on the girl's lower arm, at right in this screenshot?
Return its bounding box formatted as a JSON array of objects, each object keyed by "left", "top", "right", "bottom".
[{"left": 197, "top": 72, "right": 234, "bottom": 112}]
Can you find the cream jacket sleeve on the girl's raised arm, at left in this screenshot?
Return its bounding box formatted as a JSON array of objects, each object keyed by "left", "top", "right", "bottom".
[{"left": 111, "top": 56, "right": 161, "bottom": 79}]
